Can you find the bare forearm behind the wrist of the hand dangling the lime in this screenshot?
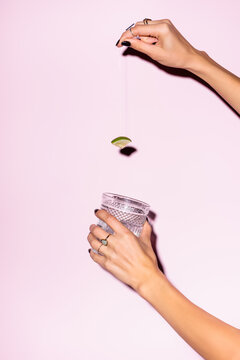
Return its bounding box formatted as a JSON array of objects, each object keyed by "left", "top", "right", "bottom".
[{"left": 187, "top": 51, "right": 240, "bottom": 113}]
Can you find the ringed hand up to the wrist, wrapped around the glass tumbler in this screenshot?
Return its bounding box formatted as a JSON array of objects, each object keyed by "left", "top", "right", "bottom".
[{"left": 88, "top": 210, "right": 160, "bottom": 292}]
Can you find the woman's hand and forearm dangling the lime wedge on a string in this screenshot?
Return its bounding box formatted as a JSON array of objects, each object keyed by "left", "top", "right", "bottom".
[{"left": 116, "top": 20, "right": 240, "bottom": 114}]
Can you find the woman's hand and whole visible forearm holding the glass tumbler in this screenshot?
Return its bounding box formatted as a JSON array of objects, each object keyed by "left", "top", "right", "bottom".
[{"left": 88, "top": 210, "right": 240, "bottom": 360}]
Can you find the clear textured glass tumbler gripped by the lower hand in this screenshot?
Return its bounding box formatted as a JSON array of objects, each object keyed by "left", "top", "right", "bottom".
[{"left": 98, "top": 193, "right": 150, "bottom": 237}]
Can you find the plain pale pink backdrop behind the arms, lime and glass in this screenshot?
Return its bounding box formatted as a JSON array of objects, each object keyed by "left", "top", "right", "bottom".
[{"left": 0, "top": 0, "right": 240, "bottom": 360}]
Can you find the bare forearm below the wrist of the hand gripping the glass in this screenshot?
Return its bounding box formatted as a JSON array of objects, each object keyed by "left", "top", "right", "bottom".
[{"left": 139, "top": 273, "right": 240, "bottom": 360}]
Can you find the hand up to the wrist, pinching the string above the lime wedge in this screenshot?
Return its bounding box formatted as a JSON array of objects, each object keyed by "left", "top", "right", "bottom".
[{"left": 117, "top": 19, "right": 200, "bottom": 69}]
